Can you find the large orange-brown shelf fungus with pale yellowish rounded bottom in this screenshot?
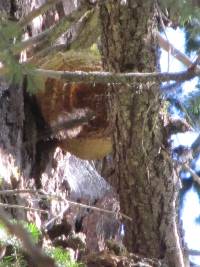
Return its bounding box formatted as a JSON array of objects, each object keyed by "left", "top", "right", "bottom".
[{"left": 37, "top": 54, "right": 112, "bottom": 159}]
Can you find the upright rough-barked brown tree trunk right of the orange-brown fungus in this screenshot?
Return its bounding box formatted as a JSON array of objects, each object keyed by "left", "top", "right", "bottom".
[{"left": 100, "top": 0, "right": 185, "bottom": 267}]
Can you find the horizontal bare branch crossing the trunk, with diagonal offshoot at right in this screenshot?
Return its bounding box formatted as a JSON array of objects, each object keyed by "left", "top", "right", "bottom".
[{"left": 0, "top": 28, "right": 200, "bottom": 84}]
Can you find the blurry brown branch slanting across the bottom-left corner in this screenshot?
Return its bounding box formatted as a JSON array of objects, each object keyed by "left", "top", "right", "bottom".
[{"left": 0, "top": 209, "right": 56, "bottom": 267}]
